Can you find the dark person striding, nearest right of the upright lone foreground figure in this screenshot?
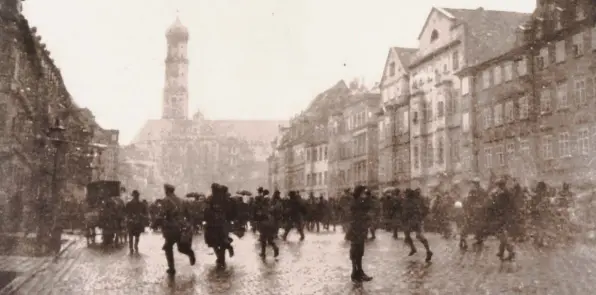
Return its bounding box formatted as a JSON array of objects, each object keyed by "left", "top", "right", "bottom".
[{"left": 402, "top": 189, "right": 433, "bottom": 262}]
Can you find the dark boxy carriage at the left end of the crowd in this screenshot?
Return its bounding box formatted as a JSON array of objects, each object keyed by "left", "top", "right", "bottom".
[{"left": 84, "top": 181, "right": 125, "bottom": 245}]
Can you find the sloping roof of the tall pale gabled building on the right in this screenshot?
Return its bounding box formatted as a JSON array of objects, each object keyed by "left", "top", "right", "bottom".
[{"left": 442, "top": 8, "right": 531, "bottom": 66}]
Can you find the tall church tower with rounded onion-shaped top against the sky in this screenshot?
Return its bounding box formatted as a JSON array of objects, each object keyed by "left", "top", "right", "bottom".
[{"left": 162, "top": 18, "right": 188, "bottom": 120}]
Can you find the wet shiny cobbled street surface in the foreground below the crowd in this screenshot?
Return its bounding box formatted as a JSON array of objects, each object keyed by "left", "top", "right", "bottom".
[{"left": 11, "top": 231, "right": 596, "bottom": 295}]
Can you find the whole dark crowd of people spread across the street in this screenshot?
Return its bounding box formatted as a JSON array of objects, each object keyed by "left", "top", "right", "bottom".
[{"left": 46, "top": 177, "right": 596, "bottom": 282}]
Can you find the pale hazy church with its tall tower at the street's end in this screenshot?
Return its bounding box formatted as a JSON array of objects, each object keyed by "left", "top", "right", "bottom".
[{"left": 120, "top": 19, "right": 284, "bottom": 199}]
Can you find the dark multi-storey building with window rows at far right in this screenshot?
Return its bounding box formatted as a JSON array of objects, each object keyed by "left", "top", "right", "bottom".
[{"left": 462, "top": 1, "right": 596, "bottom": 186}]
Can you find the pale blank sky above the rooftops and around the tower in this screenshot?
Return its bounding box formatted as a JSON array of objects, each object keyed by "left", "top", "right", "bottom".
[{"left": 24, "top": 0, "right": 535, "bottom": 143}]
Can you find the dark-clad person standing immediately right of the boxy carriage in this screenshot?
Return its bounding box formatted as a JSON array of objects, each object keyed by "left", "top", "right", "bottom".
[{"left": 125, "top": 190, "right": 147, "bottom": 254}]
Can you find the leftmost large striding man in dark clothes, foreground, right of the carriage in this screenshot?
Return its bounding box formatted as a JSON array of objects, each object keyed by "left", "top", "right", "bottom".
[{"left": 152, "top": 184, "right": 196, "bottom": 275}]
